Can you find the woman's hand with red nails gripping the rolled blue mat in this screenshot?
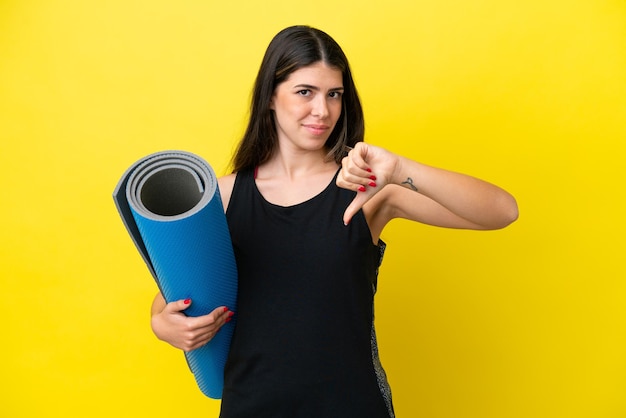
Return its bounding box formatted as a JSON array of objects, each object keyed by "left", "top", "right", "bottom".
[{"left": 151, "top": 294, "right": 234, "bottom": 352}]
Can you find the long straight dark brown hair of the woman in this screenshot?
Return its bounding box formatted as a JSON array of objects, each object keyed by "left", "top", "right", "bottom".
[{"left": 232, "top": 26, "right": 365, "bottom": 172}]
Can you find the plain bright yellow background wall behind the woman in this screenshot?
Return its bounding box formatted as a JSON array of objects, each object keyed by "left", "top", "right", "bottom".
[{"left": 0, "top": 0, "right": 626, "bottom": 418}]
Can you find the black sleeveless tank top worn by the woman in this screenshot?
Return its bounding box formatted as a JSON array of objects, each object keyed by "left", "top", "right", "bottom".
[{"left": 220, "top": 170, "right": 393, "bottom": 418}]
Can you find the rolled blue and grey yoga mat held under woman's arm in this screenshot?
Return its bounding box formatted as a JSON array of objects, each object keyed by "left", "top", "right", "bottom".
[{"left": 113, "top": 151, "right": 237, "bottom": 399}]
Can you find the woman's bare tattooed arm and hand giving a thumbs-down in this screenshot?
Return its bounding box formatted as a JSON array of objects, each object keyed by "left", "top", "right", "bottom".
[{"left": 337, "top": 143, "right": 518, "bottom": 237}]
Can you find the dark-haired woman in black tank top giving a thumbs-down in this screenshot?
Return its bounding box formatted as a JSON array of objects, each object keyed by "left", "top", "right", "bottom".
[{"left": 152, "top": 26, "right": 517, "bottom": 418}]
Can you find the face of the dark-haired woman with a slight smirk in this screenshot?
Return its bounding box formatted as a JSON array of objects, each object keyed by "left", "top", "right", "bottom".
[{"left": 270, "top": 62, "right": 344, "bottom": 150}]
